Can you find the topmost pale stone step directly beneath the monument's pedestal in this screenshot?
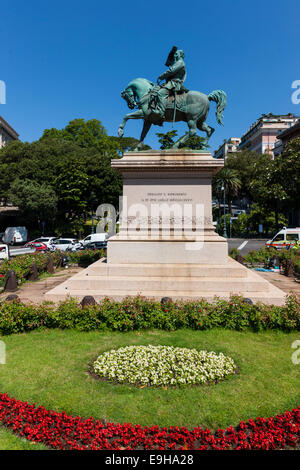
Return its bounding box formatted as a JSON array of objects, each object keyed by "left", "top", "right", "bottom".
[{"left": 86, "top": 263, "right": 247, "bottom": 278}]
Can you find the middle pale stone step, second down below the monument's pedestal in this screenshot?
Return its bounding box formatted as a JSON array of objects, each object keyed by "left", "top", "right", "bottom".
[{"left": 68, "top": 273, "right": 266, "bottom": 292}]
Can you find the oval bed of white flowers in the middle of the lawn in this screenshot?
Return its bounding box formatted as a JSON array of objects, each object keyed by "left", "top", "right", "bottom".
[{"left": 94, "top": 345, "right": 235, "bottom": 386}]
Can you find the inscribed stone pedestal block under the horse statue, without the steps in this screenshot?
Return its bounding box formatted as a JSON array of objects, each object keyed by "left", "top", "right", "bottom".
[{"left": 108, "top": 150, "right": 227, "bottom": 264}]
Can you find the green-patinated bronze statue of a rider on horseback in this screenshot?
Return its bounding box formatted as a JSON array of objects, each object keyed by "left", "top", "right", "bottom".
[{"left": 118, "top": 46, "right": 227, "bottom": 150}]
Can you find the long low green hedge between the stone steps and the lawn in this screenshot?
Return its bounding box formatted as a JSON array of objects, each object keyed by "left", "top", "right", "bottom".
[{"left": 0, "top": 294, "right": 300, "bottom": 335}]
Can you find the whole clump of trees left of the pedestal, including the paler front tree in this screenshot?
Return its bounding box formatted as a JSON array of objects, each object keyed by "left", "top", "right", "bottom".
[{"left": 0, "top": 119, "right": 122, "bottom": 234}]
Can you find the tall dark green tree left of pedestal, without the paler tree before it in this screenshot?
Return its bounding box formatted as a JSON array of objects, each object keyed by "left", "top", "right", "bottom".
[{"left": 0, "top": 120, "right": 122, "bottom": 233}]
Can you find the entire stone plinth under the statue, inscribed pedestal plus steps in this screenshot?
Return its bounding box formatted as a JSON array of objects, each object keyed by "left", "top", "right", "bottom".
[{"left": 45, "top": 150, "right": 285, "bottom": 305}]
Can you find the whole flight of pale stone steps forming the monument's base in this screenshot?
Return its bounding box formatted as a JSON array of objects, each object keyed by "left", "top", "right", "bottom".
[{"left": 45, "top": 258, "right": 286, "bottom": 305}]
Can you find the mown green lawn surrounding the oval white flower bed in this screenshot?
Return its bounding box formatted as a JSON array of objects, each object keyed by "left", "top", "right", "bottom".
[{"left": 0, "top": 329, "right": 300, "bottom": 449}]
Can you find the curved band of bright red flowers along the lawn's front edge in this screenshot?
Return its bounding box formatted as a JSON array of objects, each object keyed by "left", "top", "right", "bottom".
[{"left": 0, "top": 394, "right": 300, "bottom": 450}]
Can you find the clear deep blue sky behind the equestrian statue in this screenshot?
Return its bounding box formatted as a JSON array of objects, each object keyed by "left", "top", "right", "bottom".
[{"left": 0, "top": 0, "right": 300, "bottom": 151}]
